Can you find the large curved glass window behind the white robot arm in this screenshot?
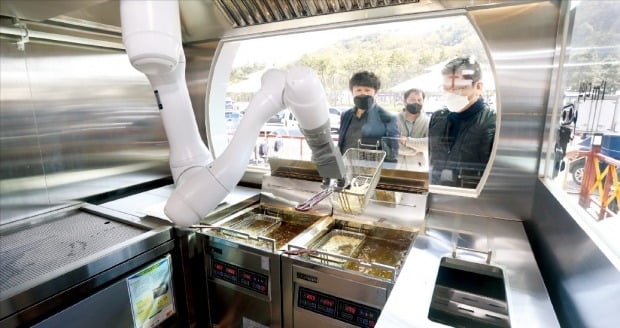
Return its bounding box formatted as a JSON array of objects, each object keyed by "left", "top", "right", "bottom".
[{"left": 206, "top": 15, "right": 497, "bottom": 194}]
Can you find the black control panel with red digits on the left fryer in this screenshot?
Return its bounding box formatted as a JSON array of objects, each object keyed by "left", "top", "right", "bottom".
[{"left": 211, "top": 260, "right": 269, "bottom": 295}]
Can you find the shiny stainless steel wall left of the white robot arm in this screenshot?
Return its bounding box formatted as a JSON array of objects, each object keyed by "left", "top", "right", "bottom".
[{"left": 0, "top": 26, "right": 169, "bottom": 223}]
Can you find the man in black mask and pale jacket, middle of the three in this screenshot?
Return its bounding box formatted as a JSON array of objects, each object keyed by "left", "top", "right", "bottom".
[{"left": 398, "top": 89, "right": 429, "bottom": 171}]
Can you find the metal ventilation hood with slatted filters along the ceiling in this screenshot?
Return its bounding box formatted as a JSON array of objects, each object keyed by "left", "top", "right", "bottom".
[{"left": 0, "top": 0, "right": 512, "bottom": 43}]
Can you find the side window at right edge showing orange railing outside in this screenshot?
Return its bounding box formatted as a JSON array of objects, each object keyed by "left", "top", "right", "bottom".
[{"left": 542, "top": 1, "right": 620, "bottom": 260}]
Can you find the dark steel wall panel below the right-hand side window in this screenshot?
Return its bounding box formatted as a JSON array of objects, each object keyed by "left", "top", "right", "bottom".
[{"left": 525, "top": 181, "right": 620, "bottom": 328}]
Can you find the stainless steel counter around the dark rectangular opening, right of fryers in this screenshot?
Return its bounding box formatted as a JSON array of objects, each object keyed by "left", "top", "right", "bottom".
[{"left": 377, "top": 211, "right": 559, "bottom": 328}]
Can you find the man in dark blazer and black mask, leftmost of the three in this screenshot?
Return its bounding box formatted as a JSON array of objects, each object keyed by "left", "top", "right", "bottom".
[{"left": 338, "top": 71, "right": 400, "bottom": 162}]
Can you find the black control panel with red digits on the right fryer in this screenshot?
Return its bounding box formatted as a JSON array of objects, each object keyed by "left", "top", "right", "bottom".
[{"left": 297, "top": 287, "right": 381, "bottom": 328}]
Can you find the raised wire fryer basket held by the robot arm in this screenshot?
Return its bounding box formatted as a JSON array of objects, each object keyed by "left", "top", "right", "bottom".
[{"left": 331, "top": 148, "right": 385, "bottom": 214}]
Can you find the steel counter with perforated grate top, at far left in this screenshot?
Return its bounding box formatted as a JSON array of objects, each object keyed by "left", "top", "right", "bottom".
[{"left": 0, "top": 203, "right": 172, "bottom": 327}]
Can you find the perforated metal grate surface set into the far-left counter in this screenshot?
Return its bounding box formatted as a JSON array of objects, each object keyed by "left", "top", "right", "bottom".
[{"left": 0, "top": 212, "right": 145, "bottom": 294}]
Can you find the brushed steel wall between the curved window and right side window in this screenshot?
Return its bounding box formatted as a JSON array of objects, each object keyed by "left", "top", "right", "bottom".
[{"left": 429, "top": 2, "right": 560, "bottom": 220}]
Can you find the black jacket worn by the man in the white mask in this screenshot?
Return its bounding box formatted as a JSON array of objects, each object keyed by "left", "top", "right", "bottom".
[{"left": 428, "top": 98, "right": 495, "bottom": 188}]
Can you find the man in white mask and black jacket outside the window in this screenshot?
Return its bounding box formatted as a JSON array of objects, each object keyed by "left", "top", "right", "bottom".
[{"left": 429, "top": 57, "right": 495, "bottom": 188}]
